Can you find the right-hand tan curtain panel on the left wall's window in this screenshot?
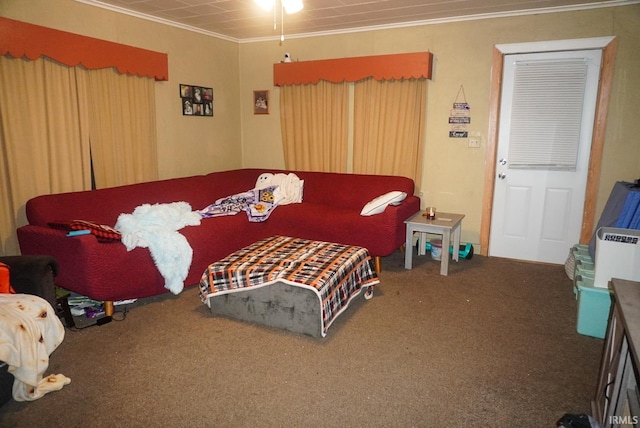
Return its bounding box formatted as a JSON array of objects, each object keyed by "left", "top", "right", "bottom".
[{"left": 78, "top": 68, "right": 158, "bottom": 188}]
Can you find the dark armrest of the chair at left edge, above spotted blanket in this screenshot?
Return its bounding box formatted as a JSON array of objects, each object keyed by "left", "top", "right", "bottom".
[{"left": 0, "top": 255, "right": 58, "bottom": 307}]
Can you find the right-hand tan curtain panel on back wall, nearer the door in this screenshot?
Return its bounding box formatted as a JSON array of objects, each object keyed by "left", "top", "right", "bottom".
[{"left": 353, "top": 78, "right": 427, "bottom": 183}]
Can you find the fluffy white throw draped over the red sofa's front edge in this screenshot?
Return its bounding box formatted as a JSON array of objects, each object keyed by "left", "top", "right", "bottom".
[{"left": 114, "top": 202, "right": 200, "bottom": 294}]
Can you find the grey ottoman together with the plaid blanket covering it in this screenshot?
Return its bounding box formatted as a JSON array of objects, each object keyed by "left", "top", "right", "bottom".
[{"left": 200, "top": 236, "right": 379, "bottom": 337}]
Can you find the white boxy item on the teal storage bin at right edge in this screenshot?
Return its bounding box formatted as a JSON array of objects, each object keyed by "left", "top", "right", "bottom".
[{"left": 593, "top": 227, "right": 640, "bottom": 288}]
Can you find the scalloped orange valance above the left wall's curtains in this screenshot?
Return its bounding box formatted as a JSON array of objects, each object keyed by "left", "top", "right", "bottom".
[{"left": 0, "top": 17, "right": 169, "bottom": 80}]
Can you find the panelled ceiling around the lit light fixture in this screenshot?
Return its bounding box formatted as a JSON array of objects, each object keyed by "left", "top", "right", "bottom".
[{"left": 76, "top": 0, "right": 636, "bottom": 41}]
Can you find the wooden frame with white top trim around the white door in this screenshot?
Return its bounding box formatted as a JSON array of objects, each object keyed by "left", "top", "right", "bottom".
[{"left": 480, "top": 37, "right": 618, "bottom": 256}]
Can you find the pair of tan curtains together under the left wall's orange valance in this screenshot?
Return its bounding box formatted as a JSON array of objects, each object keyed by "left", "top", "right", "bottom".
[{"left": 0, "top": 55, "right": 158, "bottom": 255}]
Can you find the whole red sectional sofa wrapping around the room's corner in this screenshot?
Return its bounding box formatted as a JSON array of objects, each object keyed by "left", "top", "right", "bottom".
[{"left": 17, "top": 169, "right": 420, "bottom": 310}]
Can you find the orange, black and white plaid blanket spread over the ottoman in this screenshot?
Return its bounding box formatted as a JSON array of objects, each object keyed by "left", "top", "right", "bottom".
[{"left": 200, "top": 236, "right": 380, "bottom": 336}]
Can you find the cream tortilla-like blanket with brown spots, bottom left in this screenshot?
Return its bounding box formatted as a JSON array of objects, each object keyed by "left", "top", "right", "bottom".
[{"left": 0, "top": 294, "right": 71, "bottom": 401}]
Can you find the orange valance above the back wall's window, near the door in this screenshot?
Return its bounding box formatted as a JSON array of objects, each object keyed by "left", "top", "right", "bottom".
[{"left": 273, "top": 52, "right": 433, "bottom": 86}]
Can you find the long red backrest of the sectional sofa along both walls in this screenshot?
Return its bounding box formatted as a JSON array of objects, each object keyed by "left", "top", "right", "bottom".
[{"left": 26, "top": 168, "right": 415, "bottom": 226}]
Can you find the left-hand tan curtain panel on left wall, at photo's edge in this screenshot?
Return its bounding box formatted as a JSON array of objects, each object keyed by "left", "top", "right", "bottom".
[{"left": 0, "top": 56, "right": 91, "bottom": 255}]
